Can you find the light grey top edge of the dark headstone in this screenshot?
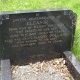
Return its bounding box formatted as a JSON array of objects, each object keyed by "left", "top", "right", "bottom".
[{"left": 0, "top": 8, "right": 70, "bottom": 15}]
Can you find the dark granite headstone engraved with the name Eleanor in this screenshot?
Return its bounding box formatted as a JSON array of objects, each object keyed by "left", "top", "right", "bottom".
[{"left": 0, "top": 8, "right": 76, "bottom": 60}]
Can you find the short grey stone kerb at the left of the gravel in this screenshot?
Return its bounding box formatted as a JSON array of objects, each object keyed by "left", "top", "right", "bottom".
[{"left": 1, "top": 59, "right": 12, "bottom": 80}]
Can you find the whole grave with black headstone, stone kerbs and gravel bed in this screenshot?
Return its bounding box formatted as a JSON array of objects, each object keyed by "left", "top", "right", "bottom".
[{"left": 0, "top": 8, "right": 80, "bottom": 80}]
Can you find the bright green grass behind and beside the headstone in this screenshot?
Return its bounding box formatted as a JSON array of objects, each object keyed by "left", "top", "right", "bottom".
[{"left": 0, "top": 0, "right": 80, "bottom": 60}]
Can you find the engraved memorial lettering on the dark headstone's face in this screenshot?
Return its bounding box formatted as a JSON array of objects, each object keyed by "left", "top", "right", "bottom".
[{"left": 4, "top": 13, "right": 68, "bottom": 47}]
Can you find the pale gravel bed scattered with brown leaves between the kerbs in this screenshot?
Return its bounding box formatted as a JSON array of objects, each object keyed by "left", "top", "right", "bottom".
[{"left": 11, "top": 58, "right": 72, "bottom": 80}]
